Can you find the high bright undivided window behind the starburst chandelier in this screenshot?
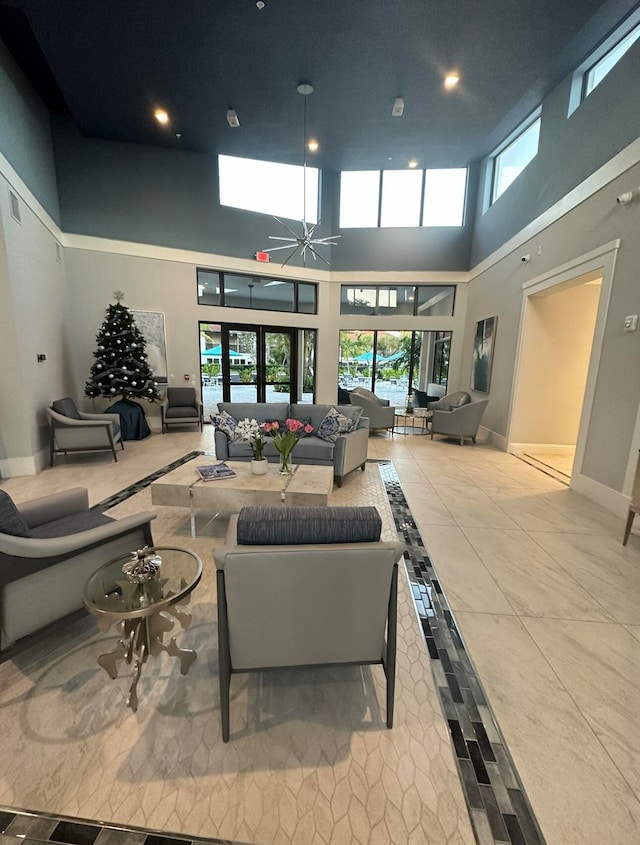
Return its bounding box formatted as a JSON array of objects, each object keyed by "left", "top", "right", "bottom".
[{"left": 218, "top": 155, "right": 318, "bottom": 223}]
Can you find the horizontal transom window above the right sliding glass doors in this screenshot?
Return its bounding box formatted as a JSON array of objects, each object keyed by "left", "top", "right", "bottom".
[{"left": 340, "top": 285, "right": 456, "bottom": 317}]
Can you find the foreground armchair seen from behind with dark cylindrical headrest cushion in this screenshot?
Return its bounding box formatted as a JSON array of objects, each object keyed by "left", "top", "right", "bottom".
[{"left": 213, "top": 506, "right": 405, "bottom": 742}]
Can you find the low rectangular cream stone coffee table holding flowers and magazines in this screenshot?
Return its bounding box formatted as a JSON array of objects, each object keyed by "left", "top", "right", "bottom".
[{"left": 151, "top": 462, "right": 333, "bottom": 537}]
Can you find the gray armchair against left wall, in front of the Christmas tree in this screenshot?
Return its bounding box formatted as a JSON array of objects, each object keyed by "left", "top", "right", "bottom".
[{"left": 47, "top": 397, "right": 124, "bottom": 466}]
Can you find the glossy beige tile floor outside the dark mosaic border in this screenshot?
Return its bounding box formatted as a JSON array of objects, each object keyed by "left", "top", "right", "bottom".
[{"left": 0, "top": 429, "right": 640, "bottom": 845}]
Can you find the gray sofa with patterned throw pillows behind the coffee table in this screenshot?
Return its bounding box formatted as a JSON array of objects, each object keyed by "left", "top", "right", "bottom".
[{"left": 215, "top": 402, "right": 369, "bottom": 487}]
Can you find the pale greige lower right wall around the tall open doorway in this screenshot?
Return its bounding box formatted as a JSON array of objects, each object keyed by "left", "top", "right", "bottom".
[{"left": 464, "top": 158, "right": 640, "bottom": 490}]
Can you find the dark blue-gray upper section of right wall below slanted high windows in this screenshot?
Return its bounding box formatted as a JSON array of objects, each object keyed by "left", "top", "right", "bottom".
[{"left": 470, "top": 37, "right": 640, "bottom": 267}]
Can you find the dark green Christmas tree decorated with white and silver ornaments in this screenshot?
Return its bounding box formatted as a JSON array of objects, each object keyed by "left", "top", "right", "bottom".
[{"left": 84, "top": 290, "right": 162, "bottom": 402}]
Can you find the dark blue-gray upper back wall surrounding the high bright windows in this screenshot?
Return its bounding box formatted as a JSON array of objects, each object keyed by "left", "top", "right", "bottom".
[{"left": 54, "top": 118, "right": 475, "bottom": 271}]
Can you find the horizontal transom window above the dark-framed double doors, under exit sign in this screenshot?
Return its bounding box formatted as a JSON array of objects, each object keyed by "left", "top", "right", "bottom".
[{"left": 196, "top": 269, "right": 317, "bottom": 314}]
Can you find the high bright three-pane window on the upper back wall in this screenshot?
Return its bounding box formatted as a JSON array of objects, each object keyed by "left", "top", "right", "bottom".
[{"left": 340, "top": 167, "right": 467, "bottom": 229}]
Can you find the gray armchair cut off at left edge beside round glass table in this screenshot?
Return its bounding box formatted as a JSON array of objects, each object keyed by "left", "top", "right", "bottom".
[{"left": 0, "top": 487, "right": 155, "bottom": 648}]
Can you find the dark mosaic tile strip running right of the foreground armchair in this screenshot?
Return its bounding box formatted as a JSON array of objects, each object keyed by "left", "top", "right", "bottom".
[{"left": 378, "top": 461, "right": 544, "bottom": 845}]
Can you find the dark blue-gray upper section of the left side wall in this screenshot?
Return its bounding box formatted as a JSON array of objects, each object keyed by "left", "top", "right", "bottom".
[{"left": 0, "top": 40, "right": 60, "bottom": 223}]
